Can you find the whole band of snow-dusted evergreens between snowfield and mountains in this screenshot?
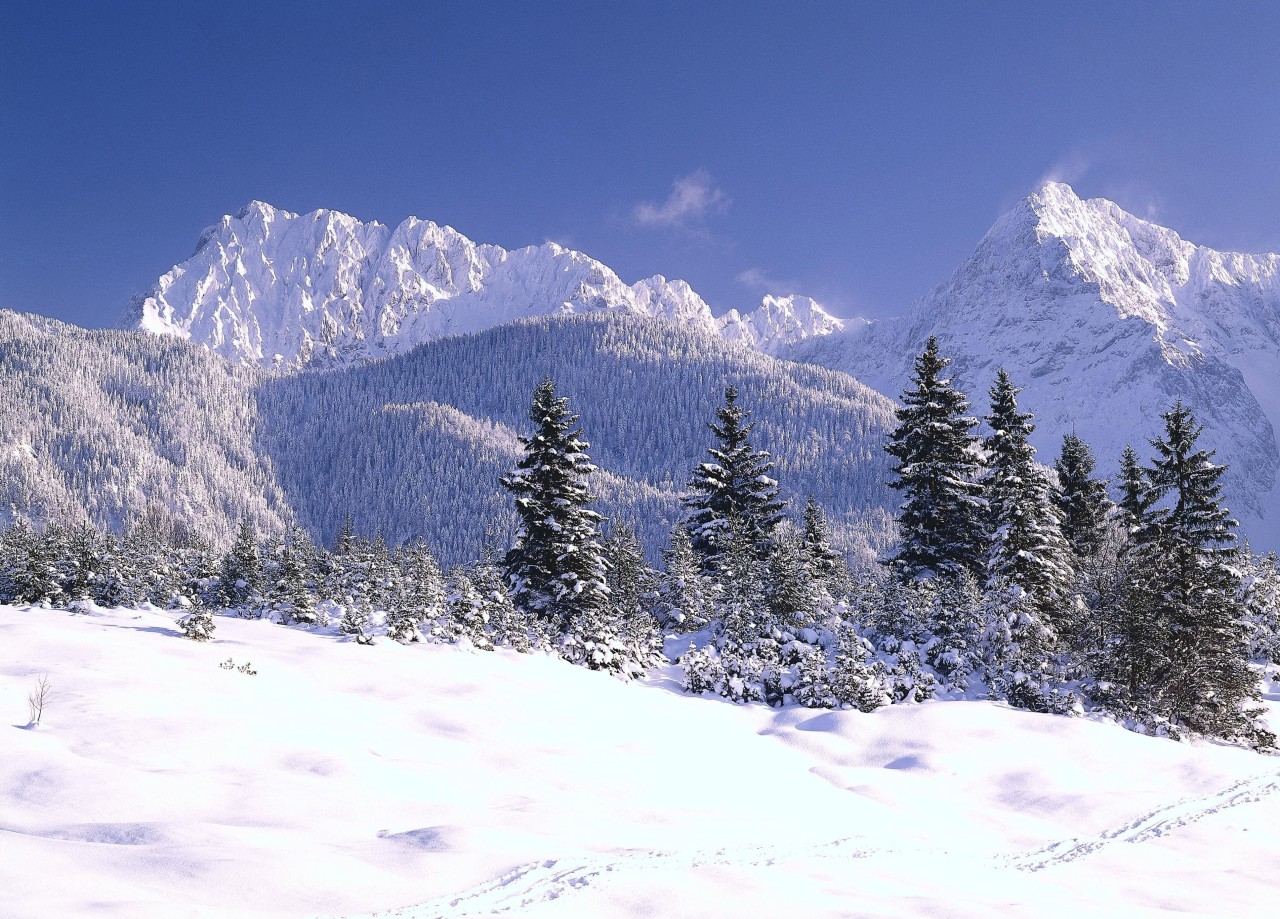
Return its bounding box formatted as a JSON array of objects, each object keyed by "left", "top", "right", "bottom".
[{"left": 0, "top": 339, "right": 1280, "bottom": 745}]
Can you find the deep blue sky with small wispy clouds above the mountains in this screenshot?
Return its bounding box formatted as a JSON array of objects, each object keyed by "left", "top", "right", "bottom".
[{"left": 0, "top": 1, "right": 1280, "bottom": 326}]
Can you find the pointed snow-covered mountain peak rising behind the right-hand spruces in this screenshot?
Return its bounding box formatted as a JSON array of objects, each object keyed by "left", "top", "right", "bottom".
[{"left": 786, "top": 183, "right": 1280, "bottom": 547}]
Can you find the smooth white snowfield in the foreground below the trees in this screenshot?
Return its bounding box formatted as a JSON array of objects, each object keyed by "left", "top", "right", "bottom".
[{"left": 0, "top": 607, "right": 1280, "bottom": 919}]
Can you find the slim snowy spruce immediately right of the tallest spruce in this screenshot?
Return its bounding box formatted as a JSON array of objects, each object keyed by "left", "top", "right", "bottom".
[{"left": 983, "top": 370, "right": 1074, "bottom": 617}]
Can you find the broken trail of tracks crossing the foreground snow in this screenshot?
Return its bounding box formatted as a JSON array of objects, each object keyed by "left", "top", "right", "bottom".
[{"left": 350, "top": 772, "right": 1280, "bottom": 919}]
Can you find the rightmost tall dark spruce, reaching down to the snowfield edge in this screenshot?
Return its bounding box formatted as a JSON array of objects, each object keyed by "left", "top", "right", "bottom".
[{"left": 1149, "top": 402, "right": 1275, "bottom": 742}]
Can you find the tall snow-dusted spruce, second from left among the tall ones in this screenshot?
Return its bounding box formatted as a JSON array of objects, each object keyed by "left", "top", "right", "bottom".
[{"left": 685, "top": 385, "right": 783, "bottom": 572}]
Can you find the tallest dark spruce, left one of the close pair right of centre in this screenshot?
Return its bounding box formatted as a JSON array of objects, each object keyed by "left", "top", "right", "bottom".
[{"left": 884, "top": 338, "right": 983, "bottom": 580}]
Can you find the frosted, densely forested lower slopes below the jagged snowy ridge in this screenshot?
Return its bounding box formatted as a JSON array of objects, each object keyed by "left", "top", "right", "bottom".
[{"left": 0, "top": 312, "right": 892, "bottom": 563}]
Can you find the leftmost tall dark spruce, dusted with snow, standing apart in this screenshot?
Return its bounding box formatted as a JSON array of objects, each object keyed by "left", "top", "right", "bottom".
[{"left": 502, "top": 379, "right": 608, "bottom": 635}]
